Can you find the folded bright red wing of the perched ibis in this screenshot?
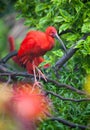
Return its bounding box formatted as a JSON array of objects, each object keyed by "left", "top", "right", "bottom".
[{"left": 18, "top": 31, "right": 45, "bottom": 57}]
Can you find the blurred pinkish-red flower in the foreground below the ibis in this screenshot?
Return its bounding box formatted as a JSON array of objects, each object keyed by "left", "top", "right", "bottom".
[{"left": 8, "top": 82, "right": 50, "bottom": 120}]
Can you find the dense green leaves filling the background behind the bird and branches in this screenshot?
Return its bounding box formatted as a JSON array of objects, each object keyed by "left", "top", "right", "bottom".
[{"left": 0, "top": 0, "right": 90, "bottom": 130}]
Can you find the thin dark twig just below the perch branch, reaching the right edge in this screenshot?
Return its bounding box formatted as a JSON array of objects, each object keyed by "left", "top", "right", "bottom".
[{"left": 46, "top": 91, "right": 90, "bottom": 102}]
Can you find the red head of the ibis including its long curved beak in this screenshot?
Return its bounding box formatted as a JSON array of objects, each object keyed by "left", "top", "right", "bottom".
[{"left": 46, "top": 26, "right": 67, "bottom": 52}]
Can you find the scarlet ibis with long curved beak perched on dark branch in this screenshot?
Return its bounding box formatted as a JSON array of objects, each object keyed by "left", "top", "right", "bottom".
[{"left": 9, "top": 26, "right": 66, "bottom": 85}]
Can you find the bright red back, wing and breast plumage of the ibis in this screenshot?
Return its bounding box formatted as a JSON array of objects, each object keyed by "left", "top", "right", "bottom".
[{"left": 18, "top": 31, "right": 54, "bottom": 59}]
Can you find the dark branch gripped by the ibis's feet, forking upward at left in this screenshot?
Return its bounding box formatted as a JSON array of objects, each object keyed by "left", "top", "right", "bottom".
[{"left": 0, "top": 51, "right": 86, "bottom": 95}]
